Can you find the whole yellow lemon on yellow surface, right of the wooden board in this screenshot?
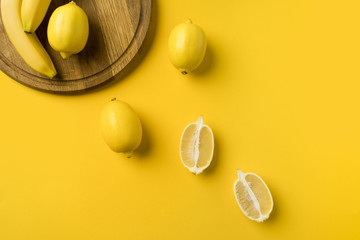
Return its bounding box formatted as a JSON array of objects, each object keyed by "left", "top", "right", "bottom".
[{"left": 168, "top": 20, "right": 206, "bottom": 74}]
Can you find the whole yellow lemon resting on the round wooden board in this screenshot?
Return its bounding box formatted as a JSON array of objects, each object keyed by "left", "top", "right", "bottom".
[{"left": 47, "top": 2, "right": 89, "bottom": 59}]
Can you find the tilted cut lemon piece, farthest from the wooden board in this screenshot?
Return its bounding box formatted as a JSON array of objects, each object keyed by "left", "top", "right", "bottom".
[{"left": 234, "top": 170, "right": 274, "bottom": 222}]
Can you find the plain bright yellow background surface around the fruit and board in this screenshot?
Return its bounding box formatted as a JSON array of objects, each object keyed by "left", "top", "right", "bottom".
[{"left": 0, "top": 0, "right": 360, "bottom": 240}]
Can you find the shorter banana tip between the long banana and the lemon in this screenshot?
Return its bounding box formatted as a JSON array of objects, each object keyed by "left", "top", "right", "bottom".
[{"left": 21, "top": 0, "right": 51, "bottom": 33}]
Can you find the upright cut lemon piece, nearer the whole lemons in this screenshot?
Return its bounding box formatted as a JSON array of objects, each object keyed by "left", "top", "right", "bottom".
[{"left": 180, "top": 117, "right": 214, "bottom": 175}]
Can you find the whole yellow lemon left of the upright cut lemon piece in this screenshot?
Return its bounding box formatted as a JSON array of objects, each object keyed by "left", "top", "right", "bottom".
[{"left": 100, "top": 98, "right": 142, "bottom": 158}]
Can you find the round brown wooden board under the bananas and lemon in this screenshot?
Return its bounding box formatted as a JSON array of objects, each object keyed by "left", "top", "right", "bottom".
[{"left": 0, "top": 0, "right": 151, "bottom": 93}]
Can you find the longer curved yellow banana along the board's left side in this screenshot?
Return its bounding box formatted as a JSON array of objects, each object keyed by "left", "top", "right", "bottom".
[{"left": 1, "top": 0, "right": 56, "bottom": 78}]
